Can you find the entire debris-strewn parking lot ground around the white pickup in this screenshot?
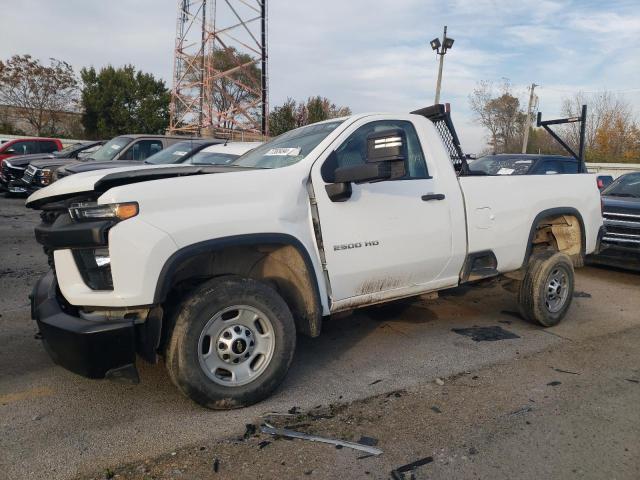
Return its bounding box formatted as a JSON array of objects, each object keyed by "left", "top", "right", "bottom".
[{"left": 0, "top": 198, "right": 640, "bottom": 479}]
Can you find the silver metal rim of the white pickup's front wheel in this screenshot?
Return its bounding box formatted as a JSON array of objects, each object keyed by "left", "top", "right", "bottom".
[{"left": 198, "top": 305, "right": 275, "bottom": 387}]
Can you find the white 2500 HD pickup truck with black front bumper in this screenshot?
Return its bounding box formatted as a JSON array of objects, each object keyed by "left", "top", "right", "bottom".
[{"left": 27, "top": 105, "right": 602, "bottom": 409}]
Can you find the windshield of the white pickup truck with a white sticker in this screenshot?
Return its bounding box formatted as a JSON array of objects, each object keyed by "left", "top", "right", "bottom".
[{"left": 231, "top": 120, "right": 343, "bottom": 168}]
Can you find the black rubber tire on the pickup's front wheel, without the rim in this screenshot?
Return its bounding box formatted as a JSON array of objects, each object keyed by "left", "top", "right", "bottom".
[{"left": 165, "top": 277, "right": 296, "bottom": 410}]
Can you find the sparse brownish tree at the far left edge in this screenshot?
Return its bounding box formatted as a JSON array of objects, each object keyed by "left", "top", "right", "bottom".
[{"left": 0, "top": 55, "right": 78, "bottom": 135}]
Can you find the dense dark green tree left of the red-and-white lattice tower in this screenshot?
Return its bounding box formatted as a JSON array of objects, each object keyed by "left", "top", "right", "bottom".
[{"left": 80, "top": 65, "right": 170, "bottom": 138}]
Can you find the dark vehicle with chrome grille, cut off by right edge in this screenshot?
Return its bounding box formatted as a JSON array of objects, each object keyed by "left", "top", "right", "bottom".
[{"left": 589, "top": 172, "right": 640, "bottom": 270}]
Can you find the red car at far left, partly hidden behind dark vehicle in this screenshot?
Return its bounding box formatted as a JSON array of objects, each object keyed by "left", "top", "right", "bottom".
[{"left": 0, "top": 138, "right": 62, "bottom": 191}]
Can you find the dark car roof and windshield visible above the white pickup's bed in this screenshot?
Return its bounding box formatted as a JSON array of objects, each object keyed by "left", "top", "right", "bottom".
[{"left": 469, "top": 153, "right": 587, "bottom": 175}]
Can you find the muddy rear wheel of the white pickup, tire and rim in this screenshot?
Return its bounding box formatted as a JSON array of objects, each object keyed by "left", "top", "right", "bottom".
[{"left": 518, "top": 252, "right": 574, "bottom": 327}]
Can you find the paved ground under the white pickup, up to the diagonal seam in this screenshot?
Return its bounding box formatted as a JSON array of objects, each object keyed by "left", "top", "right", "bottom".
[{"left": 0, "top": 198, "right": 640, "bottom": 479}]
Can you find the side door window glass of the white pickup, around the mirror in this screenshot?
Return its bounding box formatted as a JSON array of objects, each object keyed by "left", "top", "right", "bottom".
[{"left": 322, "top": 120, "right": 429, "bottom": 182}]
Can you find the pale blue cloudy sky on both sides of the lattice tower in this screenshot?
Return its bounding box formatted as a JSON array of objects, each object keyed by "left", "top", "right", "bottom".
[{"left": 0, "top": 0, "right": 640, "bottom": 152}]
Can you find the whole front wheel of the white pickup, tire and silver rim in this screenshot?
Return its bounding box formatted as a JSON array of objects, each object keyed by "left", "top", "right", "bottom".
[{"left": 165, "top": 277, "right": 296, "bottom": 410}]
